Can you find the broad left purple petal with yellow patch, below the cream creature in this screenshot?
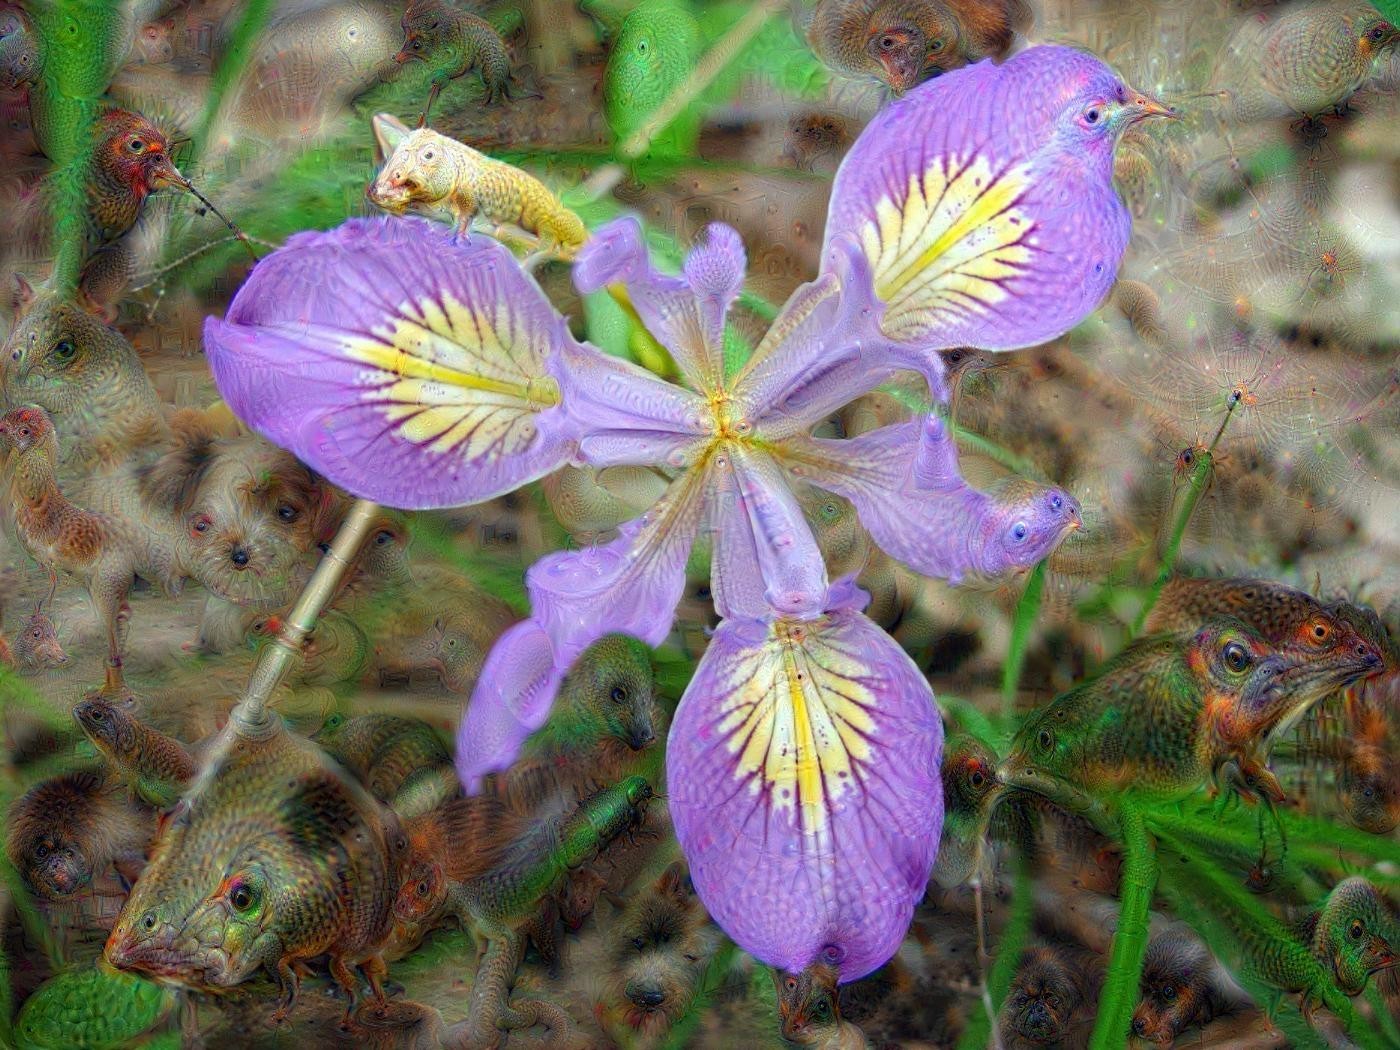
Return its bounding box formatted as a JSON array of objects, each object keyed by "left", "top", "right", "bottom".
[{"left": 204, "top": 218, "right": 577, "bottom": 508}]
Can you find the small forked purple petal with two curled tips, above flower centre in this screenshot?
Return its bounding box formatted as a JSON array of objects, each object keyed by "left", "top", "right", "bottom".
[{"left": 574, "top": 216, "right": 746, "bottom": 391}]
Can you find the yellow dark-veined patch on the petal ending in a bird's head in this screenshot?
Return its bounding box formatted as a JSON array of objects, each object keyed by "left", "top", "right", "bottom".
[{"left": 861, "top": 157, "right": 1033, "bottom": 335}]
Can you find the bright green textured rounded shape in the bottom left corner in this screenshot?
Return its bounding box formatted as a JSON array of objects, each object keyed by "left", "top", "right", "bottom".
[{"left": 15, "top": 966, "right": 175, "bottom": 1050}]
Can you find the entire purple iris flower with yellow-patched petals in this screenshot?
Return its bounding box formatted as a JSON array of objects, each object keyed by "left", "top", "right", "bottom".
[{"left": 204, "top": 48, "right": 1166, "bottom": 981}]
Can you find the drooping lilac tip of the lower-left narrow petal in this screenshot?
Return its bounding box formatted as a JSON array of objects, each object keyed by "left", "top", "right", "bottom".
[{"left": 456, "top": 620, "right": 568, "bottom": 794}]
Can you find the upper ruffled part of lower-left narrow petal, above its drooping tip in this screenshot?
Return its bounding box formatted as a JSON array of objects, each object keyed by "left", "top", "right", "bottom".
[{"left": 525, "top": 465, "right": 710, "bottom": 669}]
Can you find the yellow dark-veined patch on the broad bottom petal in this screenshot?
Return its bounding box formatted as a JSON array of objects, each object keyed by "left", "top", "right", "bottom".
[{"left": 718, "top": 620, "right": 875, "bottom": 839}]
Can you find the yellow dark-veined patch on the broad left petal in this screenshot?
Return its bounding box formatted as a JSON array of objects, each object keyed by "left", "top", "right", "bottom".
[{"left": 344, "top": 295, "right": 560, "bottom": 459}]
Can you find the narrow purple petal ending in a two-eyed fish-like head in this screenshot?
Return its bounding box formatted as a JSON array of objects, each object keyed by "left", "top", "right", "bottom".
[{"left": 780, "top": 416, "right": 1079, "bottom": 582}]
